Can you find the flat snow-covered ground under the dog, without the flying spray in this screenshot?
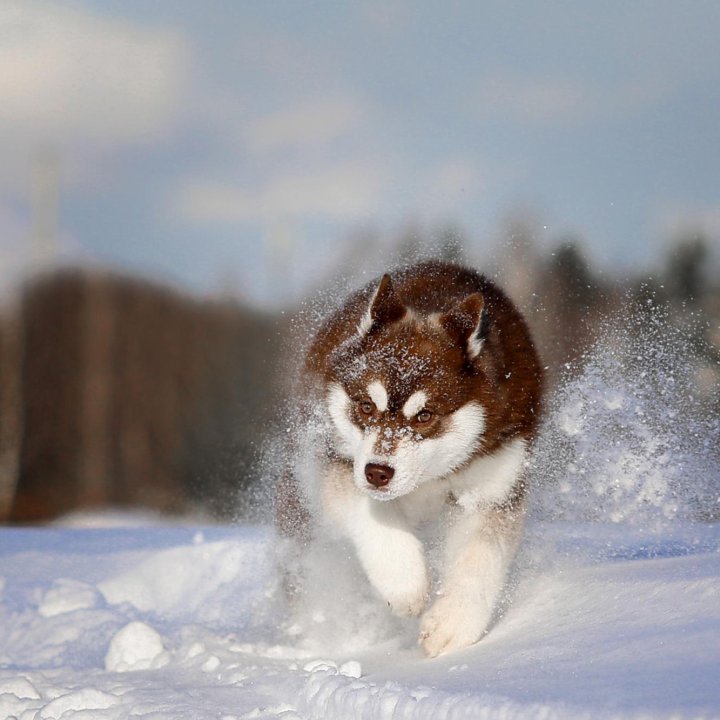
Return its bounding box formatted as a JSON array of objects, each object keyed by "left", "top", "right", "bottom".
[{"left": 0, "top": 522, "right": 720, "bottom": 720}]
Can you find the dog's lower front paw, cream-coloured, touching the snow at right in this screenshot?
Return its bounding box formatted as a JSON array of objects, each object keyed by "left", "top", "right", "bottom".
[{"left": 420, "top": 595, "right": 490, "bottom": 657}]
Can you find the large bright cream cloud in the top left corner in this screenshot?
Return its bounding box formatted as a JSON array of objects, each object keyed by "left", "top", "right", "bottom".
[{"left": 0, "top": 0, "right": 187, "bottom": 146}]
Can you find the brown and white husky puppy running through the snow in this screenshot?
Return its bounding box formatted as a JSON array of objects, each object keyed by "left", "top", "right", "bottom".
[{"left": 278, "top": 262, "right": 542, "bottom": 657}]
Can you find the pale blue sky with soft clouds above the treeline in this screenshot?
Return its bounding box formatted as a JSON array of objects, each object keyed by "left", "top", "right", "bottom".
[{"left": 0, "top": 0, "right": 720, "bottom": 305}]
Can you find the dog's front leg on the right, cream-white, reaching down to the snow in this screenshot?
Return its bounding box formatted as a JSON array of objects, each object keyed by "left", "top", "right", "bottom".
[{"left": 420, "top": 508, "right": 524, "bottom": 657}]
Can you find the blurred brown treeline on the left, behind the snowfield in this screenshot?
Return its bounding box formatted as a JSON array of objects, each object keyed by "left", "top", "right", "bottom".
[{"left": 0, "top": 270, "right": 277, "bottom": 522}]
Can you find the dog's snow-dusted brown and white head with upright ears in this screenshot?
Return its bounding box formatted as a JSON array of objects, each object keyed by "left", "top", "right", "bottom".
[{"left": 327, "top": 276, "right": 486, "bottom": 500}]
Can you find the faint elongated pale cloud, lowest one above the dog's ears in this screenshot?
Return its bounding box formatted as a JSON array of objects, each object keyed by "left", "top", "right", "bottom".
[{"left": 173, "top": 162, "right": 381, "bottom": 223}]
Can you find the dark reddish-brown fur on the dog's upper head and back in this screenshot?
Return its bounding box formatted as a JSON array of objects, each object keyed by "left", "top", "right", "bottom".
[{"left": 306, "top": 262, "right": 542, "bottom": 454}]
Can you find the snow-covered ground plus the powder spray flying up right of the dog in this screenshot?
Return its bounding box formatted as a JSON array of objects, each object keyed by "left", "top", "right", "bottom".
[{"left": 0, "top": 306, "right": 720, "bottom": 720}]
